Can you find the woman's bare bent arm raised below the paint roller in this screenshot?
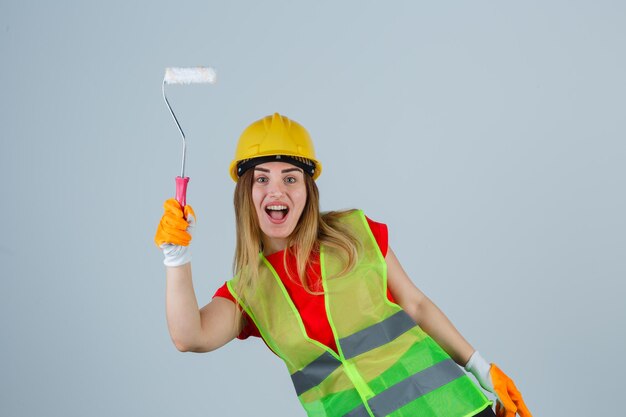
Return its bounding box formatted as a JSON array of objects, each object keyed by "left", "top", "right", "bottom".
[{"left": 165, "top": 262, "right": 241, "bottom": 352}]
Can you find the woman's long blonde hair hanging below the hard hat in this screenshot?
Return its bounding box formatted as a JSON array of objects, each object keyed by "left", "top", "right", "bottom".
[{"left": 233, "top": 169, "right": 359, "bottom": 294}]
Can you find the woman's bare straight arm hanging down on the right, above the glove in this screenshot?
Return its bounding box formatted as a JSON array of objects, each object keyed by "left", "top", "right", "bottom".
[{"left": 385, "top": 248, "right": 474, "bottom": 366}]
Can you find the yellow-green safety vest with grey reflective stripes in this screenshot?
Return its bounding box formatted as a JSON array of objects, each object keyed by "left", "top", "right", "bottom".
[{"left": 228, "top": 210, "right": 490, "bottom": 417}]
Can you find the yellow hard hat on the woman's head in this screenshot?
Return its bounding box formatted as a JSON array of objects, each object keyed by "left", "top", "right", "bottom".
[{"left": 229, "top": 113, "right": 322, "bottom": 182}]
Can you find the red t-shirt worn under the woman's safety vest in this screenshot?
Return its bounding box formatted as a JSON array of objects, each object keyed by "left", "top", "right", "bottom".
[{"left": 213, "top": 217, "right": 394, "bottom": 352}]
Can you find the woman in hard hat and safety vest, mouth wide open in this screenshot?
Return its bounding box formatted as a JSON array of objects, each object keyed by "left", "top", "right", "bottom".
[{"left": 155, "top": 113, "right": 531, "bottom": 417}]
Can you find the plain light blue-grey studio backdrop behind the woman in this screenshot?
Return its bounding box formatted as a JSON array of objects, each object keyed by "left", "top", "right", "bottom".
[{"left": 0, "top": 0, "right": 626, "bottom": 417}]
